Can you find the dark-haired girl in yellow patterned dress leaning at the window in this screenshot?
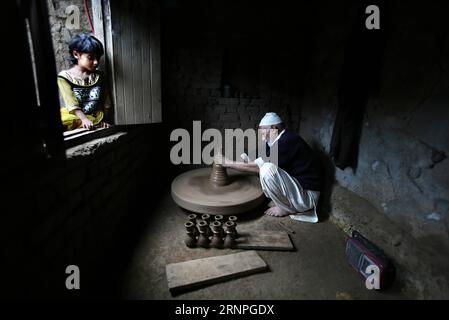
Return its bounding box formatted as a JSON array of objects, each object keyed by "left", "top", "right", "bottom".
[{"left": 58, "top": 33, "right": 111, "bottom": 130}]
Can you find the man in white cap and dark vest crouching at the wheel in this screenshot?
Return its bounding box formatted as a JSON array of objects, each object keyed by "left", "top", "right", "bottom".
[{"left": 215, "top": 112, "right": 321, "bottom": 223}]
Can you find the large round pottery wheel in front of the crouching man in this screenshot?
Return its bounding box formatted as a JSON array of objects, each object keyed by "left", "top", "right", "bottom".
[{"left": 171, "top": 166, "right": 264, "bottom": 215}]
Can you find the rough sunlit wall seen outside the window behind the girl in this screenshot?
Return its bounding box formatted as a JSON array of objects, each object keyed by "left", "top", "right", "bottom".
[{"left": 47, "top": 0, "right": 92, "bottom": 72}]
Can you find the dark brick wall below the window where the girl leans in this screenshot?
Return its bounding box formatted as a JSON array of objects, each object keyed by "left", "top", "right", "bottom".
[{"left": 1, "top": 126, "right": 165, "bottom": 298}]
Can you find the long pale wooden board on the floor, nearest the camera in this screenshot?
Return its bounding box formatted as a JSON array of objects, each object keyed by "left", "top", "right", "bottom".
[{"left": 165, "top": 251, "right": 268, "bottom": 293}]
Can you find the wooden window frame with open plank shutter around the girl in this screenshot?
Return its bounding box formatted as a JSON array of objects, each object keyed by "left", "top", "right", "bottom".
[{"left": 14, "top": 0, "right": 162, "bottom": 157}]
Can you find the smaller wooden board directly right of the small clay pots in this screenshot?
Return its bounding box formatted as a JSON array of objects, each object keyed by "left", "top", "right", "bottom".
[{"left": 236, "top": 231, "right": 294, "bottom": 251}]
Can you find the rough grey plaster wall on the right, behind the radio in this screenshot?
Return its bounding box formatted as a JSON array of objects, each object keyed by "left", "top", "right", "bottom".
[{"left": 301, "top": 1, "right": 449, "bottom": 248}]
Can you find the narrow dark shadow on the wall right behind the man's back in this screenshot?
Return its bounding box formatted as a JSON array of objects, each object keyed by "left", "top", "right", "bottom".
[{"left": 310, "top": 142, "right": 336, "bottom": 221}]
